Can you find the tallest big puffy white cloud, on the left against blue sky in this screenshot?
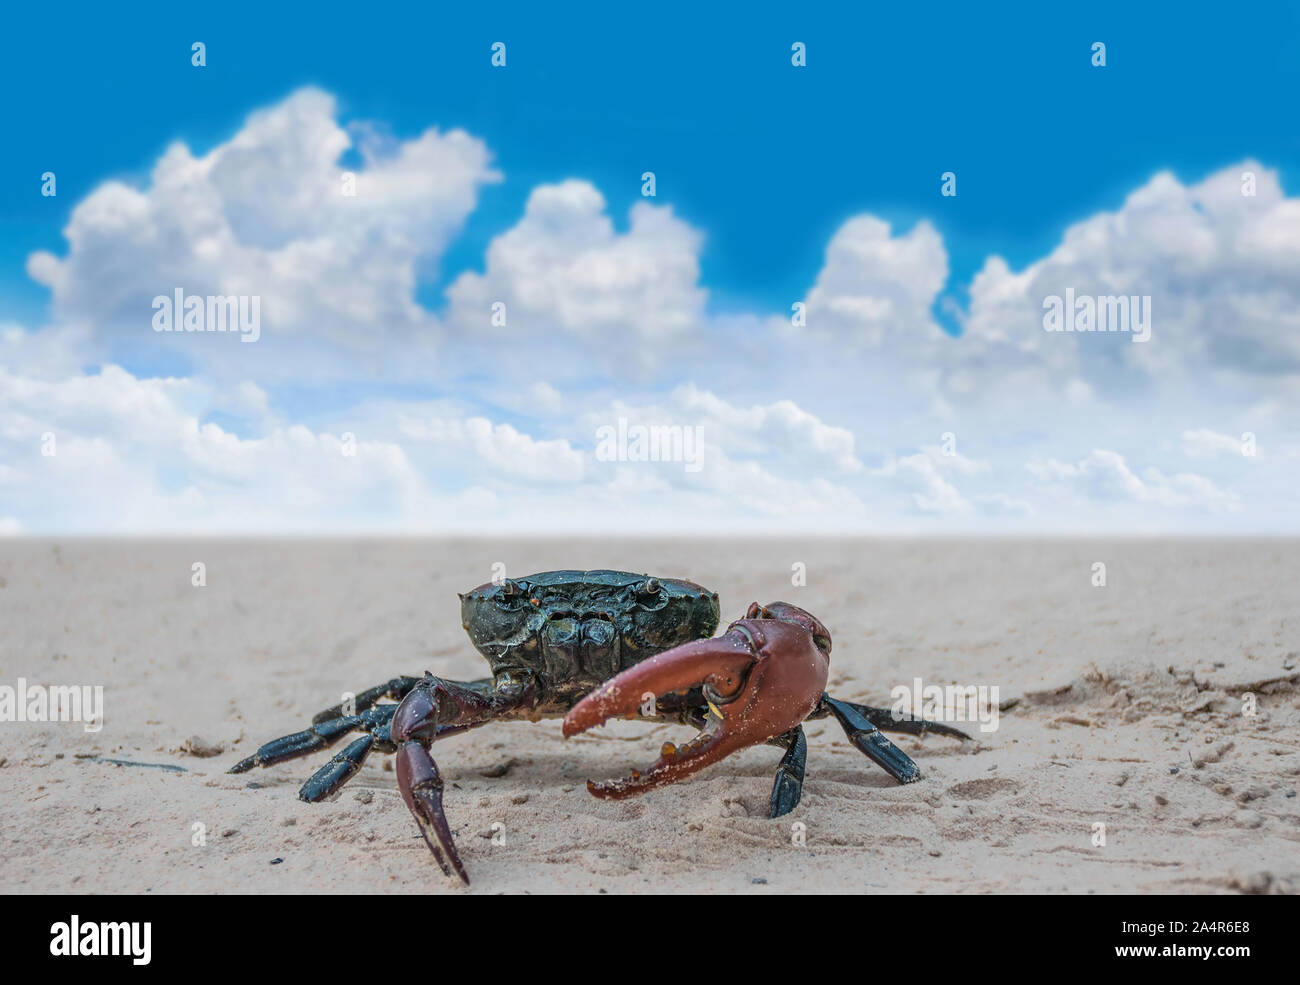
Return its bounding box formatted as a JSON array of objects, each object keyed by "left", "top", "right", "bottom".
[{"left": 27, "top": 88, "right": 499, "bottom": 372}]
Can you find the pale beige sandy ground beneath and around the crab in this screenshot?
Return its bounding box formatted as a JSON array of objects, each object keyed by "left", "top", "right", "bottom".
[{"left": 0, "top": 539, "right": 1300, "bottom": 894}]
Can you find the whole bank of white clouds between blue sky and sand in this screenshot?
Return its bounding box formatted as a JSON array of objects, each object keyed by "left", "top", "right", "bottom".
[{"left": 0, "top": 88, "right": 1300, "bottom": 534}]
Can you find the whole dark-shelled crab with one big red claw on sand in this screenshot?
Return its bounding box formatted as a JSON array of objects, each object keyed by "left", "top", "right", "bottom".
[{"left": 230, "top": 570, "right": 970, "bottom": 885}]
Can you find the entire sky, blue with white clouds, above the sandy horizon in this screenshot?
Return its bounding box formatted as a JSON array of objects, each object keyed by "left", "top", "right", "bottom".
[{"left": 0, "top": 4, "right": 1300, "bottom": 534}]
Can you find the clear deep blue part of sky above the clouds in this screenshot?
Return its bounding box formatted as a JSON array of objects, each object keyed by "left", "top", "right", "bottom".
[{"left": 10, "top": 3, "right": 1300, "bottom": 330}]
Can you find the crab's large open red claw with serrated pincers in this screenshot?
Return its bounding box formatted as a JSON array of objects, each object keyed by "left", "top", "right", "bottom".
[{"left": 564, "top": 602, "right": 831, "bottom": 799}]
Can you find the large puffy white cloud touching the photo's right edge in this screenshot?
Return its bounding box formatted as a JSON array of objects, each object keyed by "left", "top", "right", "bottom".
[{"left": 949, "top": 161, "right": 1300, "bottom": 390}]
